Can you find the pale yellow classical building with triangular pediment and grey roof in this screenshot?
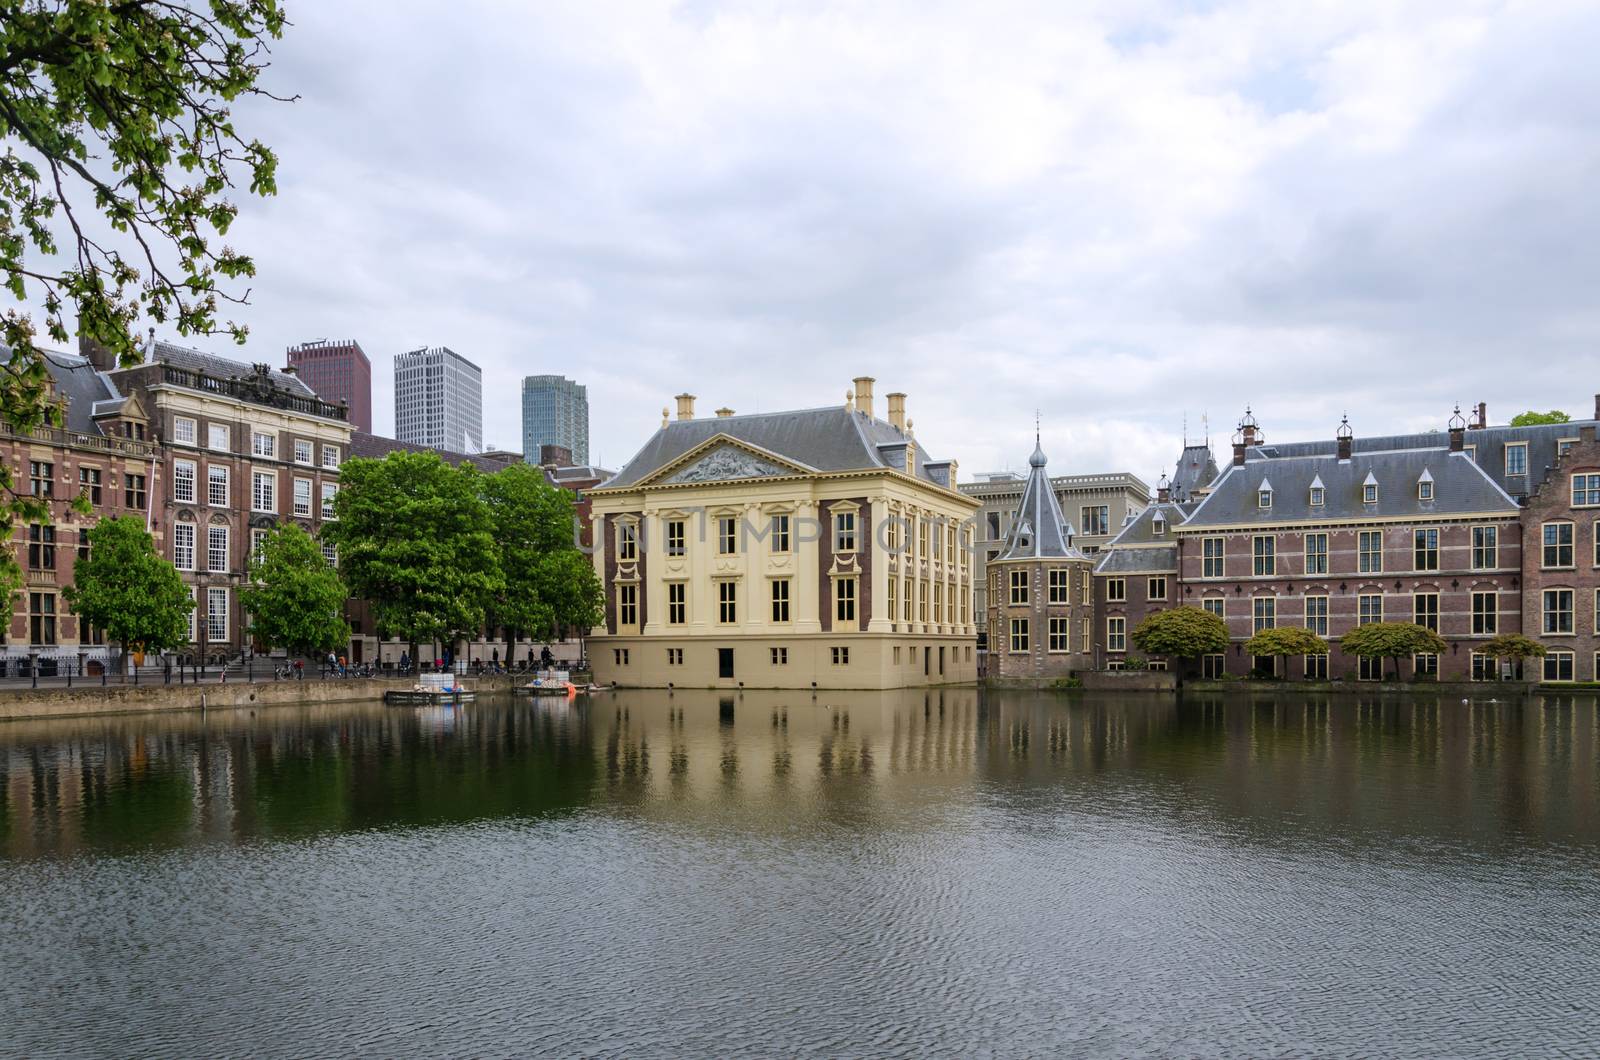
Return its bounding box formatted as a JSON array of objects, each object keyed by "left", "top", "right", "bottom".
[{"left": 589, "top": 376, "right": 979, "bottom": 689}]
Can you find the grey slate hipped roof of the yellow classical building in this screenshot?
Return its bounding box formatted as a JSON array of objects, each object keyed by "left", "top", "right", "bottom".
[{"left": 600, "top": 405, "right": 944, "bottom": 490}]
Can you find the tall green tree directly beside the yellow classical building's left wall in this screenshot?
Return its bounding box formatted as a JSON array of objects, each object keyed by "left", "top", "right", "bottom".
[{"left": 482, "top": 464, "right": 605, "bottom": 663}]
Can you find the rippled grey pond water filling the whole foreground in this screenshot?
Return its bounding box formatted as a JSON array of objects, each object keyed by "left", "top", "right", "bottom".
[{"left": 0, "top": 690, "right": 1600, "bottom": 1057}]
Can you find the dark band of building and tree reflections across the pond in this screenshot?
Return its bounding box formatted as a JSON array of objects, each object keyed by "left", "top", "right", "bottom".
[{"left": 0, "top": 689, "right": 1600, "bottom": 858}]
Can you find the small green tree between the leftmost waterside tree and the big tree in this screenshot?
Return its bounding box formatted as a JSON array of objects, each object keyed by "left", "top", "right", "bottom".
[{"left": 238, "top": 522, "right": 350, "bottom": 656}]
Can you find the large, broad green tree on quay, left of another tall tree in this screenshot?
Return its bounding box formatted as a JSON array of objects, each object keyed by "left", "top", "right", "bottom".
[{"left": 322, "top": 453, "right": 502, "bottom": 658}]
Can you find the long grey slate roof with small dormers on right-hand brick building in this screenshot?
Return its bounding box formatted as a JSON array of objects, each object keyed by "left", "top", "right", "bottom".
[{"left": 1184, "top": 447, "right": 1517, "bottom": 530}]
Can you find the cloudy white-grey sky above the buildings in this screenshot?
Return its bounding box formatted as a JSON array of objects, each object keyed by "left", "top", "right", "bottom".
[{"left": 206, "top": 0, "right": 1600, "bottom": 480}]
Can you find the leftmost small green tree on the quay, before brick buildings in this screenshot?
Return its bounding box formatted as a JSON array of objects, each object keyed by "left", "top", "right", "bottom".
[{"left": 61, "top": 516, "right": 195, "bottom": 682}]
